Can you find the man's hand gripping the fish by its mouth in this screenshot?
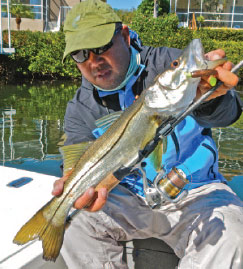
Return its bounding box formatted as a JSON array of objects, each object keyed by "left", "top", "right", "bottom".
[{"left": 196, "top": 49, "right": 239, "bottom": 101}]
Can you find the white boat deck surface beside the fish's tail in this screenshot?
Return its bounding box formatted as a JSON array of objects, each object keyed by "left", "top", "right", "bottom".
[{"left": 0, "top": 166, "right": 66, "bottom": 269}]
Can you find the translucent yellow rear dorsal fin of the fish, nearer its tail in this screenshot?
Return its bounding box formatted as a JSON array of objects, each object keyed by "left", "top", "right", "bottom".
[{"left": 60, "top": 141, "right": 93, "bottom": 176}]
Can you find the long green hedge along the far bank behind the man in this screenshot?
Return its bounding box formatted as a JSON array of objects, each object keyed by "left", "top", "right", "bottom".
[{"left": 0, "top": 17, "right": 243, "bottom": 80}]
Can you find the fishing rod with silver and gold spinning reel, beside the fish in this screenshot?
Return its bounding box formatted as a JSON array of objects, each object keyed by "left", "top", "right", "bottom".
[{"left": 113, "top": 61, "right": 243, "bottom": 208}]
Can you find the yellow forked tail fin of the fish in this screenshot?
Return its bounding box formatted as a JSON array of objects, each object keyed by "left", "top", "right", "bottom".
[{"left": 13, "top": 203, "right": 65, "bottom": 261}]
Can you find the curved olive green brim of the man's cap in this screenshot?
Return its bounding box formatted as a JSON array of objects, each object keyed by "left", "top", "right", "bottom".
[{"left": 63, "top": 23, "right": 116, "bottom": 61}]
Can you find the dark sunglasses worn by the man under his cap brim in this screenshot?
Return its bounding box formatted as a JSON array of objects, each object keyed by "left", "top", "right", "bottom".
[{"left": 71, "top": 27, "right": 122, "bottom": 63}]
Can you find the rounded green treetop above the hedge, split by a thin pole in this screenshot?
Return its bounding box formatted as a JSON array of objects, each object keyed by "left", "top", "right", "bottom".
[{"left": 137, "top": 0, "right": 170, "bottom": 16}]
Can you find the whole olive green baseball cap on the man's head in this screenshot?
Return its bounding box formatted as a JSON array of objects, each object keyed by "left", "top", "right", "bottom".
[{"left": 63, "top": 0, "right": 121, "bottom": 60}]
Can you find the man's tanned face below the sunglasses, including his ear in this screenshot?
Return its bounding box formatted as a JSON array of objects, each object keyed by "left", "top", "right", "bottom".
[{"left": 77, "top": 27, "right": 130, "bottom": 90}]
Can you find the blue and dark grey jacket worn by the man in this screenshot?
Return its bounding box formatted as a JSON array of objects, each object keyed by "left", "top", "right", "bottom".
[{"left": 65, "top": 34, "right": 242, "bottom": 195}]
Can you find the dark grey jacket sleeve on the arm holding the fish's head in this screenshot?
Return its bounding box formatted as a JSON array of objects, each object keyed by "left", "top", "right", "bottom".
[{"left": 192, "top": 89, "right": 242, "bottom": 128}]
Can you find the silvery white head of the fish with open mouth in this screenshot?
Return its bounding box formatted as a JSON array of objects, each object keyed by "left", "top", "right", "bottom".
[{"left": 145, "top": 39, "right": 226, "bottom": 115}]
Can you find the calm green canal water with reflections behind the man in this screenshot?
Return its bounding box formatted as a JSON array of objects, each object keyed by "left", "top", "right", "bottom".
[{"left": 0, "top": 82, "right": 243, "bottom": 179}]
